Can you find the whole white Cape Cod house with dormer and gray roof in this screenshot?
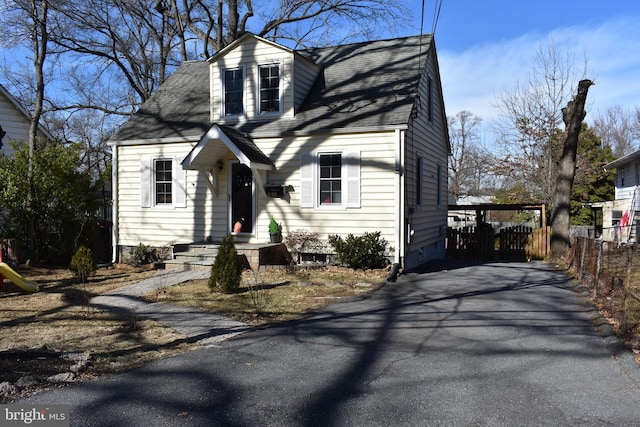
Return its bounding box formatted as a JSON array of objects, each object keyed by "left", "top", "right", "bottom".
[{"left": 110, "top": 34, "right": 449, "bottom": 269}]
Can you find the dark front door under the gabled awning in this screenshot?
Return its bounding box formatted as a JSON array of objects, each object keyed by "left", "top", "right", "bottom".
[{"left": 229, "top": 162, "right": 254, "bottom": 233}]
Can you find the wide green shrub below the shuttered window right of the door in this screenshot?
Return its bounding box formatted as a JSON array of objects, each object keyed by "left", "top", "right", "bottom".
[{"left": 329, "top": 231, "right": 387, "bottom": 269}]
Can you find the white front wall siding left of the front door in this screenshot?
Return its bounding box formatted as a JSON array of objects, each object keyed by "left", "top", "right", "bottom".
[{"left": 114, "top": 143, "right": 232, "bottom": 246}]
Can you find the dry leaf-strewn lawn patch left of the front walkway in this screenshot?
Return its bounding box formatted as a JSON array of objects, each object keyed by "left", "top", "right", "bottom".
[{"left": 0, "top": 266, "right": 197, "bottom": 403}]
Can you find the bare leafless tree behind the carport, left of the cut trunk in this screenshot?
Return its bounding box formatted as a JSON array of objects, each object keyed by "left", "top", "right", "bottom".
[{"left": 496, "top": 43, "right": 586, "bottom": 209}]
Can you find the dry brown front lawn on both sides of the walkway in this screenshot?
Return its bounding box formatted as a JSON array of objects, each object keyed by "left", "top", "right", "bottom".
[{"left": 0, "top": 265, "right": 386, "bottom": 403}]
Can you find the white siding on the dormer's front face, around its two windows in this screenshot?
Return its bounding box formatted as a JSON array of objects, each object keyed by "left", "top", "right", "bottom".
[{"left": 210, "top": 37, "right": 294, "bottom": 121}]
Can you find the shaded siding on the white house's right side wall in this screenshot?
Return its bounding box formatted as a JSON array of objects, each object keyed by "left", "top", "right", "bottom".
[{"left": 405, "top": 48, "right": 448, "bottom": 266}]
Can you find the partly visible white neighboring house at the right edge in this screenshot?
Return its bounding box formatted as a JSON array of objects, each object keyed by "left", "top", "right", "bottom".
[{"left": 593, "top": 150, "right": 640, "bottom": 243}]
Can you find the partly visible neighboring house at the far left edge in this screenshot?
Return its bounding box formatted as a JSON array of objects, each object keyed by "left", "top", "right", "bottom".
[{"left": 0, "top": 85, "right": 53, "bottom": 156}]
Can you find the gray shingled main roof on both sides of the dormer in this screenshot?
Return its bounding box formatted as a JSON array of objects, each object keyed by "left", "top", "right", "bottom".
[{"left": 112, "top": 36, "right": 432, "bottom": 141}]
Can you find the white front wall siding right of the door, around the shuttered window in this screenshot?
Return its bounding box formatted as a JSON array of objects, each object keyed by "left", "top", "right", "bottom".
[{"left": 255, "top": 131, "right": 398, "bottom": 246}]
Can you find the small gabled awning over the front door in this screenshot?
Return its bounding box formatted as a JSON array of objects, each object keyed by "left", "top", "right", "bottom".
[{"left": 182, "top": 123, "right": 274, "bottom": 170}]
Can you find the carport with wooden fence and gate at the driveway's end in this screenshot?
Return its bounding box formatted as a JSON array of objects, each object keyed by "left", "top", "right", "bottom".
[{"left": 447, "top": 203, "right": 551, "bottom": 261}]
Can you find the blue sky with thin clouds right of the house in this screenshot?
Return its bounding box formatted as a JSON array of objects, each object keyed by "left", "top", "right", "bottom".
[{"left": 401, "top": 0, "right": 640, "bottom": 130}]
